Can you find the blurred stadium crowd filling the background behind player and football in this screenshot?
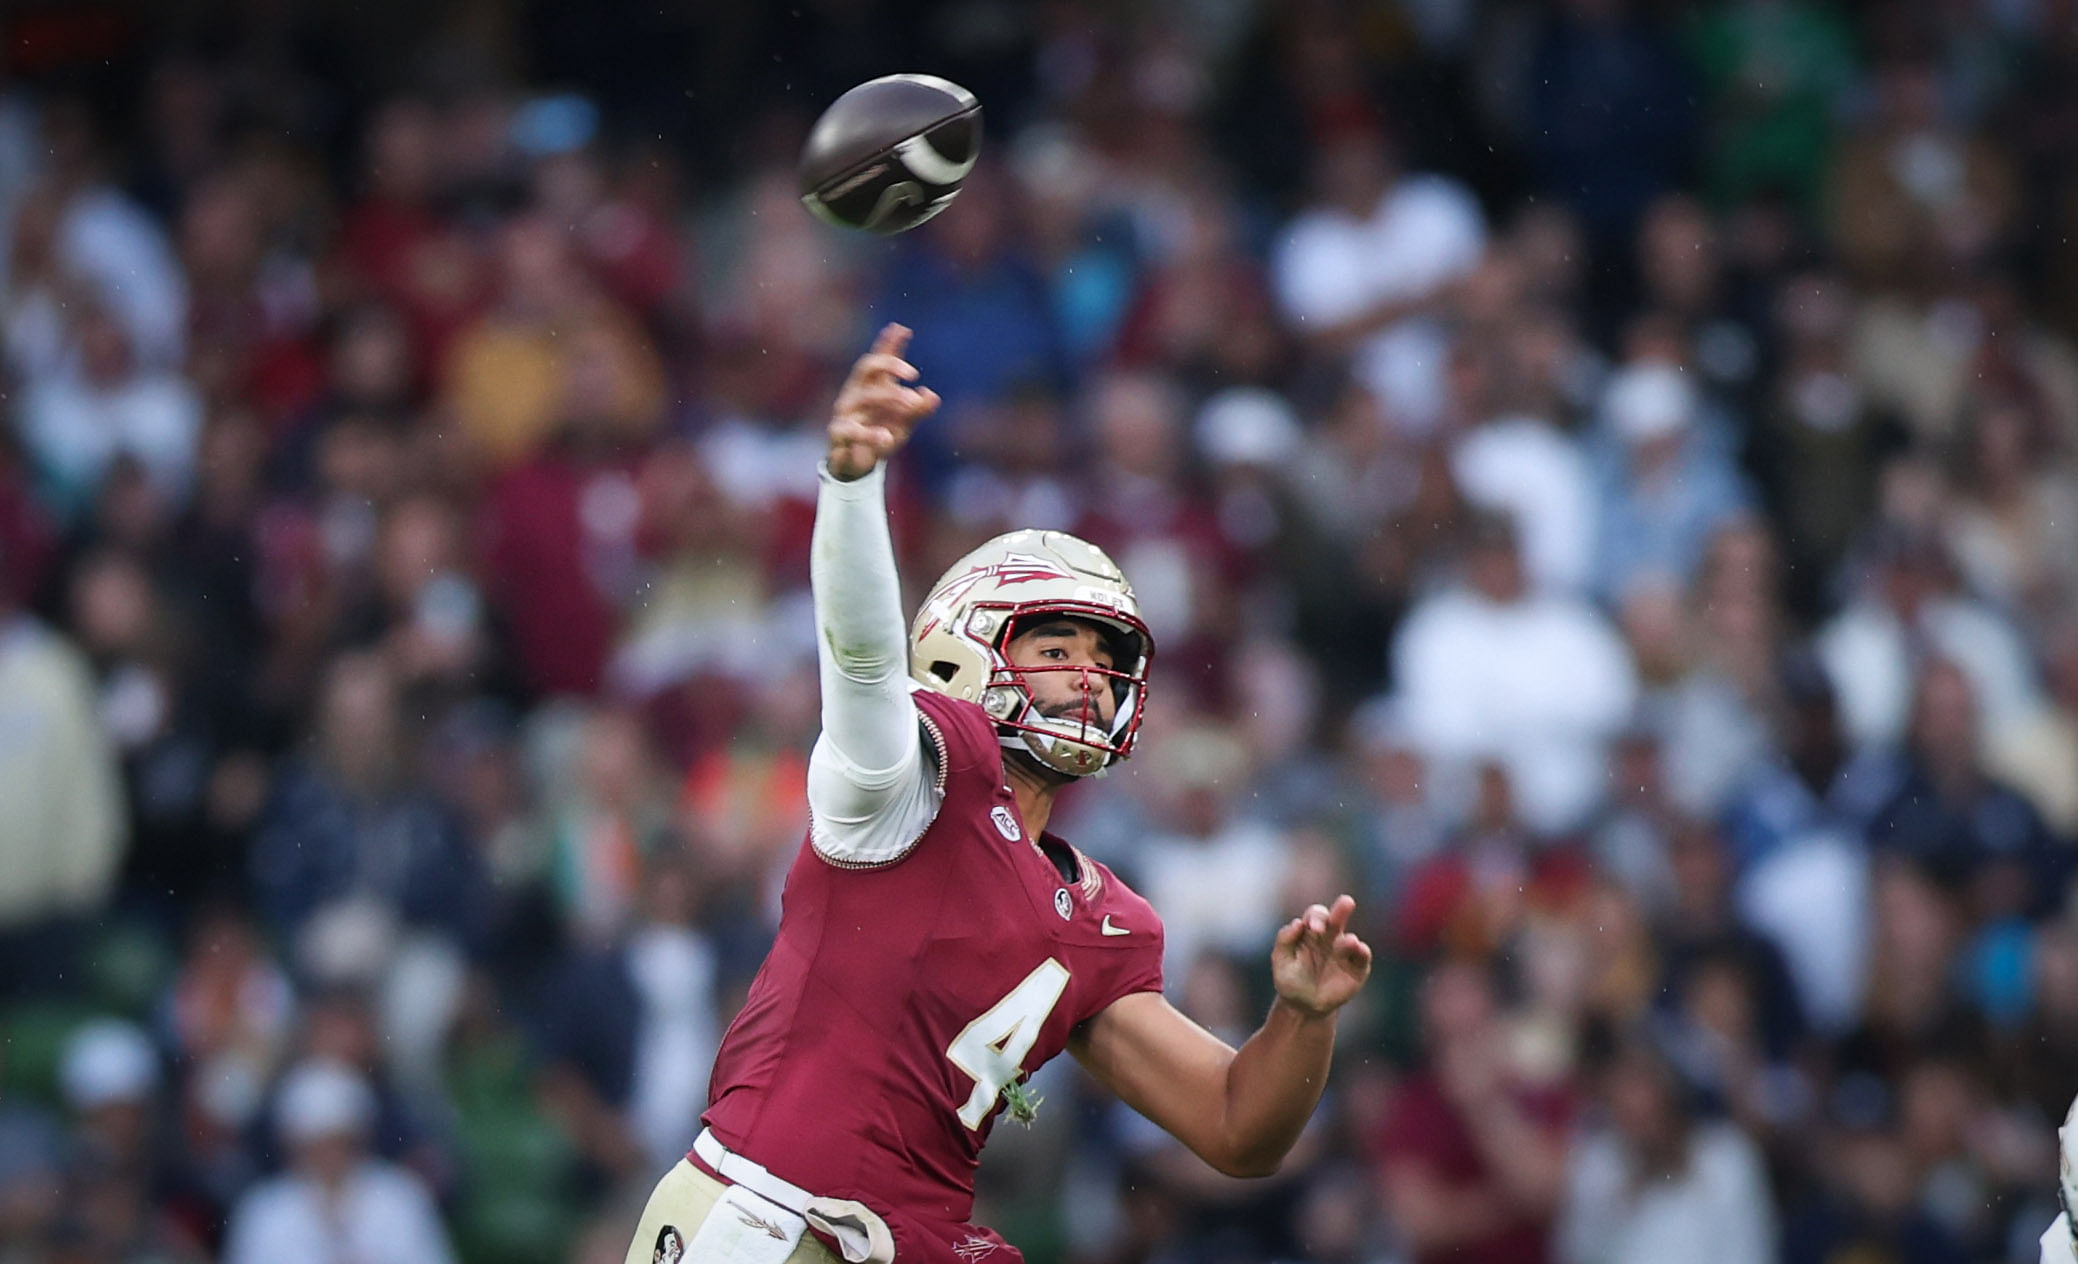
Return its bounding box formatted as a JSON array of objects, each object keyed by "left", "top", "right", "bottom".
[{"left": 0, "top": 0, "right": 2078, "bottom": 1264}]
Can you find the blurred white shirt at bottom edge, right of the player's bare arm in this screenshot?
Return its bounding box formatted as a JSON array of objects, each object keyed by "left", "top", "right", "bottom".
[{"left": 1554, "top": 1123, "right": 1775, "bottom": 1264}]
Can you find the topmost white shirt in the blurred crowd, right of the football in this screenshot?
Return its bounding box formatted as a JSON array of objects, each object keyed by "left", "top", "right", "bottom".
[{"left": 1272, "top": 175, "right": 1486, "bottom": 432}]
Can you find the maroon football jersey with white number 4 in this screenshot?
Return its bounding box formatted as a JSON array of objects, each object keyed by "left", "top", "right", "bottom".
[{"left": 707, "top": 692, "right": 1162, "bottom": 1264}]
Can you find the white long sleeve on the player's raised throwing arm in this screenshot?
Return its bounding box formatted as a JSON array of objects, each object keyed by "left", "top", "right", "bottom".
[{"left": 808, "top": 468, "right": 943, "bottom": 865}]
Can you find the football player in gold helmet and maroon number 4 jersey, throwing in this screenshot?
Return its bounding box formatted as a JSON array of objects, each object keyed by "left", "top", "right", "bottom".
[{"left": 628, "top": 324, "right": 1371, "bottom": 1264}]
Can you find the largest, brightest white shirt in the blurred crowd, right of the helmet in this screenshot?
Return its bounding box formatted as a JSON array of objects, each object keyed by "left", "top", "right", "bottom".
[{"left": 1392, "top": 588, "right": 1637, "bottom": 832}]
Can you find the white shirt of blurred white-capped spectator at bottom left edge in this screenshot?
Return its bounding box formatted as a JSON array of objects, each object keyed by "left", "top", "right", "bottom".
[{"left": 224, "top": 1162, "right": 453, "bottom": 1264}]
